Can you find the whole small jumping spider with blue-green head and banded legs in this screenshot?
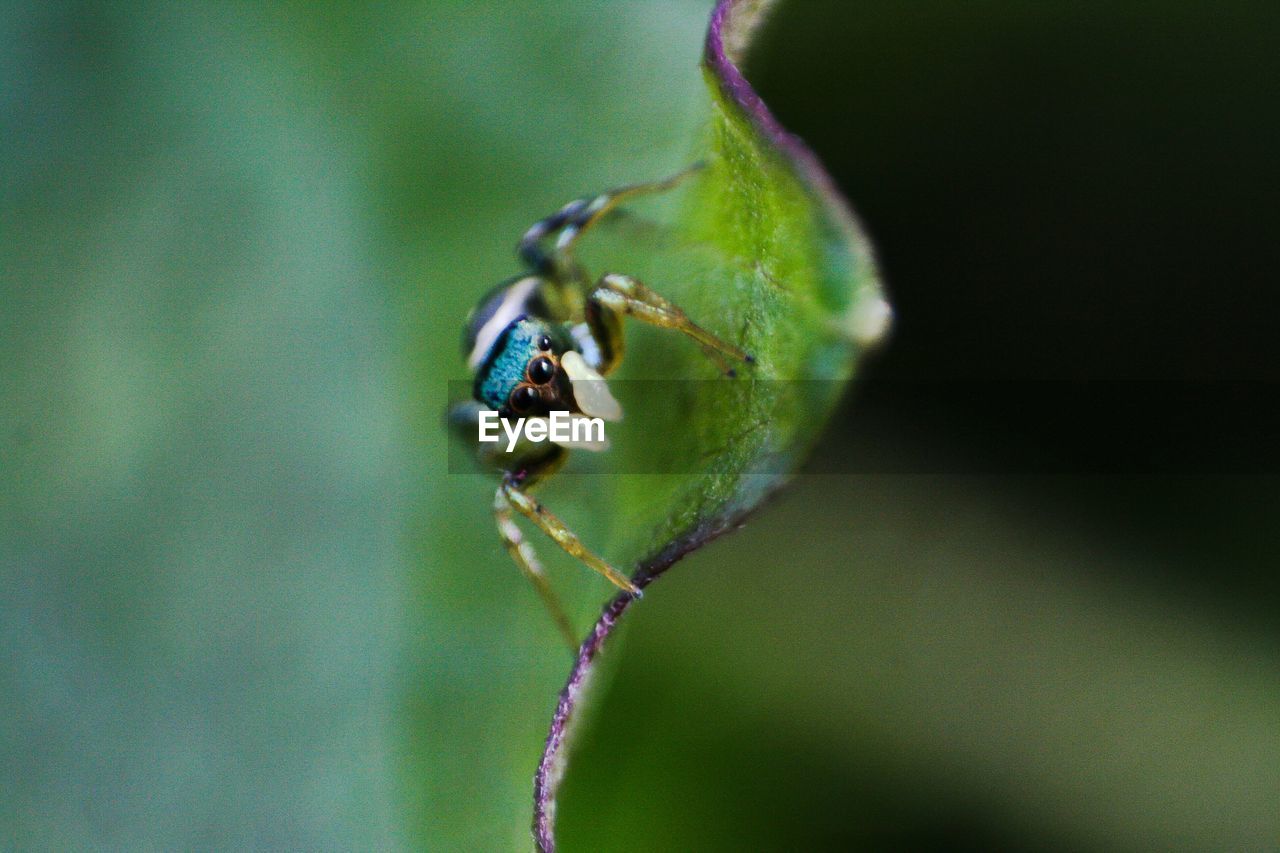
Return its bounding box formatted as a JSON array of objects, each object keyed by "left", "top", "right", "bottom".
[{"left": 451, "top": 172, "right": 753, "bottom": 647}]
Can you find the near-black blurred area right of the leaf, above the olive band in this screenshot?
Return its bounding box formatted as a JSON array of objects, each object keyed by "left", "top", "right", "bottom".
[{"left": 753, "top": 0, "right": 1280, "bottom": 596}]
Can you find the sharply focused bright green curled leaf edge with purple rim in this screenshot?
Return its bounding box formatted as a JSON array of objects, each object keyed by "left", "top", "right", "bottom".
[{"left": 519, "top": 0, "right": 888, "bottom": 849}]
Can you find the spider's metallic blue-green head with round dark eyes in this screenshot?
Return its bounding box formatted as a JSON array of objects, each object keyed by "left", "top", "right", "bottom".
[{"left": 475, "top": 316, "right": 567, "bottom": 416}]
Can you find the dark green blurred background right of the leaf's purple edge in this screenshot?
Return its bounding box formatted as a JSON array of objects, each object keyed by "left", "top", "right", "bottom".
[{"left": 567, "top": 0, "right": 1280, "bottom": 850}]
